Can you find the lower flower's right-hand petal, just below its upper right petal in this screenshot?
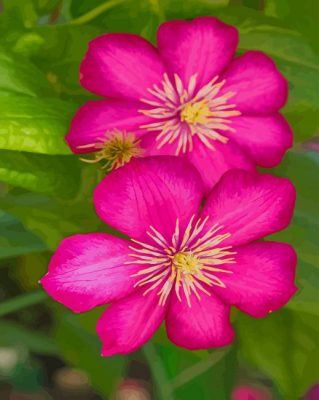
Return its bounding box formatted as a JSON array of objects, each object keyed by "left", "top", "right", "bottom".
[{"left": 213, "top": 242, "right": 297, "bottom": 317}]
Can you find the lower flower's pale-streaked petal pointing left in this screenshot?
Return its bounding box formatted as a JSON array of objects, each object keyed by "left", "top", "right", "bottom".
[{"left": 41, "top": 233, "right": 140, "bottom": 312}]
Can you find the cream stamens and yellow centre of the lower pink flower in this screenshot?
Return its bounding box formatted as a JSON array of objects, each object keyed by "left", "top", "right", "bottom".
[{"left": 126, "top": 216, "right": 235, "bottom": 307}]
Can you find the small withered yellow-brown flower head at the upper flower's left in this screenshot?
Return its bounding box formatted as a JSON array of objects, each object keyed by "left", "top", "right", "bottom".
[{"left": 82, "top": 130, "right": 142, "bottom": 171}]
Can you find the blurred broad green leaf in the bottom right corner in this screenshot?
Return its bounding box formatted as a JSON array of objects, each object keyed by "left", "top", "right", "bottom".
[{"left": 237, "top": 310, "right": 319, "bottom": 399}]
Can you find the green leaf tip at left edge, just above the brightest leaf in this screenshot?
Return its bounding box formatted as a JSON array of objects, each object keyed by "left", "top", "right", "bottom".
[{"left": 0, "top": 48, "right": 53, "bottom": 97}]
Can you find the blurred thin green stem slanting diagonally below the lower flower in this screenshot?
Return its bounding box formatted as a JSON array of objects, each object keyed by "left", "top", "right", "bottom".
[{"left": 171, "top": 349, "right": 229, "bottom": 389}]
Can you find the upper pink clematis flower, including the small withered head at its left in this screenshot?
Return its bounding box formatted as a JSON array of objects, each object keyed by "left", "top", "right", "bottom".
[{"left": 66, "top": 17, "right": 292, "bottom": 190}]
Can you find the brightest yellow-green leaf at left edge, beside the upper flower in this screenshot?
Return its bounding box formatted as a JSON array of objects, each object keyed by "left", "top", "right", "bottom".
[{"left": 0, "top": 95, "right": 75, "bottom": 154}]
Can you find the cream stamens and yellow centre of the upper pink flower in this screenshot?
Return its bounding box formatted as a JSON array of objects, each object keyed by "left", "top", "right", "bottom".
[{"left": 139, "top": 74, "right": 240, "bottom": 155}]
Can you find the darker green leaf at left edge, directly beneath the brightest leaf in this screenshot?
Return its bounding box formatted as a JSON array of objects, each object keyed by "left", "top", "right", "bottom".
[{"left": 0, "top": 150, "right": 80, "bottom": 198}]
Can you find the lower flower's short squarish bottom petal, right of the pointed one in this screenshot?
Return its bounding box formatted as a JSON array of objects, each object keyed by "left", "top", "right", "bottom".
[{"left": 166, "top": 292, "right": 234, "bottom": 350}]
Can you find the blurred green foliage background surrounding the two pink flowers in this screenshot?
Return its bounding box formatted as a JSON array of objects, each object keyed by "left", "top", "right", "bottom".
[{"left": 0, "top": 0, "right": 319, "bottom": 400}]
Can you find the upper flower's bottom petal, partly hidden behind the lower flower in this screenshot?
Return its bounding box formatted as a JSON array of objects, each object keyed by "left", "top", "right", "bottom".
[{"left": 187, "top": 137, "right": 255, "bottom": 192}]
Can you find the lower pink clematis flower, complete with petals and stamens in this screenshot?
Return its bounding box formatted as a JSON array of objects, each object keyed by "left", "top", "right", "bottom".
[{"left": 41, "top": 156, "right": 296, "bottom": 355}]
